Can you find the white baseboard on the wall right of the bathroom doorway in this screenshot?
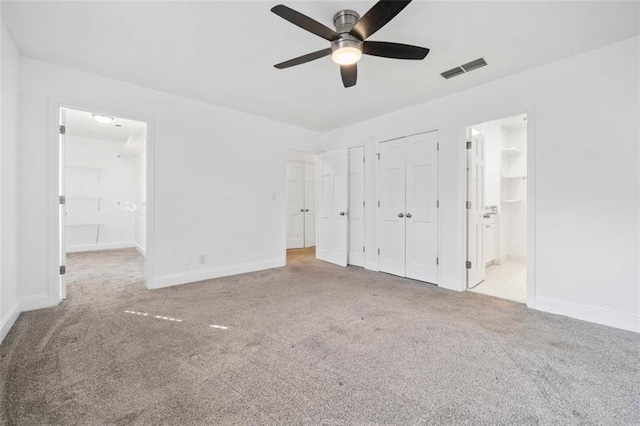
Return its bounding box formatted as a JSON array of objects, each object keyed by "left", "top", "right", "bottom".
[{"left": 535, "top": 296, "right": 640, "bottom": 332}]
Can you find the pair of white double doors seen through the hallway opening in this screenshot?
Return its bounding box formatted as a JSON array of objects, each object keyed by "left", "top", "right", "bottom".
[{"left": 287, "top": 161, "right": 316, "bottom": 249}]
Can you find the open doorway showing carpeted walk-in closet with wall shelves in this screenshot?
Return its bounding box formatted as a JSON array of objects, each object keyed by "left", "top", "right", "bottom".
[{"left": 59, "top": 107, "right": 147, "bottom": 300}]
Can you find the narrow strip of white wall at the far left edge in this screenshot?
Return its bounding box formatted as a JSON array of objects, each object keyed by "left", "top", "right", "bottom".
[{"left": 0, "top": 16, "right": 20, "bottom": 342}]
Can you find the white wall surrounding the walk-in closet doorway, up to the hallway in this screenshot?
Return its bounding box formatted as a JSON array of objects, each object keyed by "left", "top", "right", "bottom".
[{"left": 18, "top": 57, "right": 318, "bottom": 309}]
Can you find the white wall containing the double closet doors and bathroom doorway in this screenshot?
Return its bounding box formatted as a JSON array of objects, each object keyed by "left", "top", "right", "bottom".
[{"left": 321, "top": 37, "right": 640, "bottom": 330}]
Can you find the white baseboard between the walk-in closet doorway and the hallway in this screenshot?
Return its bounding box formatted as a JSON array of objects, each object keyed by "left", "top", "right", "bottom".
[{"left": 147, "top": 257, "right": 286, "bottom": 290}]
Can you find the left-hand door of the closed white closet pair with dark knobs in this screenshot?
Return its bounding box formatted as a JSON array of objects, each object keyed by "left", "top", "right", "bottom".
[{"left": 378, "top": 138, "right": 406, "bottom": 277}]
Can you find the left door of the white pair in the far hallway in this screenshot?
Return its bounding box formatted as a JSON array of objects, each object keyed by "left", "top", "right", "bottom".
[{"left": 287, "top": 161, "right": 305, "bottom": 249}]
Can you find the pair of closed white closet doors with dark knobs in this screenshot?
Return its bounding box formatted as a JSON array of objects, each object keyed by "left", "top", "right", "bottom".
[{"left": 378, "top": 132, "right": 438, "bottom": 283}]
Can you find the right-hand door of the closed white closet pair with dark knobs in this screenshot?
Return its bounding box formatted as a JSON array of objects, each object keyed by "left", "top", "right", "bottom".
[{"left": 405, "top": 132, "right": 438, "bottom": 283}]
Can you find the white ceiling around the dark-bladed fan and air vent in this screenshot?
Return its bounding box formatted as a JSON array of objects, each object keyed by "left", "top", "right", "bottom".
[{"left": 2, "top": 0, "right": 639, "bottom": 131}]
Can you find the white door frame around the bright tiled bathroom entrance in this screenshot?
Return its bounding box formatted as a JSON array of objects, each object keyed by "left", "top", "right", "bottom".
[{"left": 458, "top": 104, "right": 536, "bottom": 309}]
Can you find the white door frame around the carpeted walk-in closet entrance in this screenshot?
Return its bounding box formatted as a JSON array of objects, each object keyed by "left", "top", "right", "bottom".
[{"left": 47, "top": 98, "right": 155, "bottom": 306}]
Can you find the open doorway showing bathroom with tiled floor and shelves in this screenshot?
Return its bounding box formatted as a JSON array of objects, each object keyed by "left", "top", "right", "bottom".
[{"left": 466, "top": 114, "right": 528, "bottom": 303}]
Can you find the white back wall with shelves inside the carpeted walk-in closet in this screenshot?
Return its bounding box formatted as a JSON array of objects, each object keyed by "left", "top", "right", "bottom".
[{"left": 65, "top": 135, "right": 137, "bottom": 252}]
